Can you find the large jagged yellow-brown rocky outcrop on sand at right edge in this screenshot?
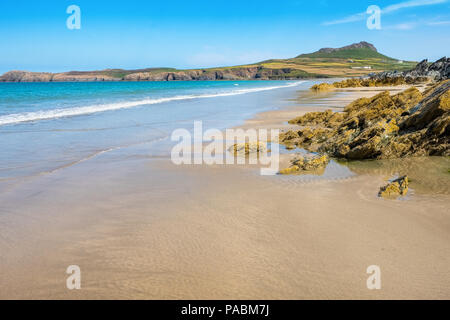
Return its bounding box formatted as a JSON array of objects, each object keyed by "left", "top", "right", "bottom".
[{"left": 280, "top": 80, "right": 450, "bottom": 160}]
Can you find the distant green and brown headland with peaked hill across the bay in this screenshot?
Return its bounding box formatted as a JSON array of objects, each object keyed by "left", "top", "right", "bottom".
[{"left": 0, "top": 41, "right": 416, "bottom": 82}]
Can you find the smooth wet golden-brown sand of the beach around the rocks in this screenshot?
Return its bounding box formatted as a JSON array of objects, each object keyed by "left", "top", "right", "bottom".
[{"left": 0, "top": 84, "right": 450, "bottom": 299}]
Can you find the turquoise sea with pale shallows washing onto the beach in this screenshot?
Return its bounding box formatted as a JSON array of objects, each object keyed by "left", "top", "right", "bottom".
[{"left": 0, "top": 81, "right": 311, "bottom": 182}]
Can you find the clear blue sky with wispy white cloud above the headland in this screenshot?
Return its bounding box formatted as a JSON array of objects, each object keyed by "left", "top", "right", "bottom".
[{"left": 0, "top": 0, "right": 450, "bottom": 73}]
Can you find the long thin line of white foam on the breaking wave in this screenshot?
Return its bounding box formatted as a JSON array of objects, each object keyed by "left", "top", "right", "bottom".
[{"left": 0, "top": 81, "right": 304, "bottom": 126}]
